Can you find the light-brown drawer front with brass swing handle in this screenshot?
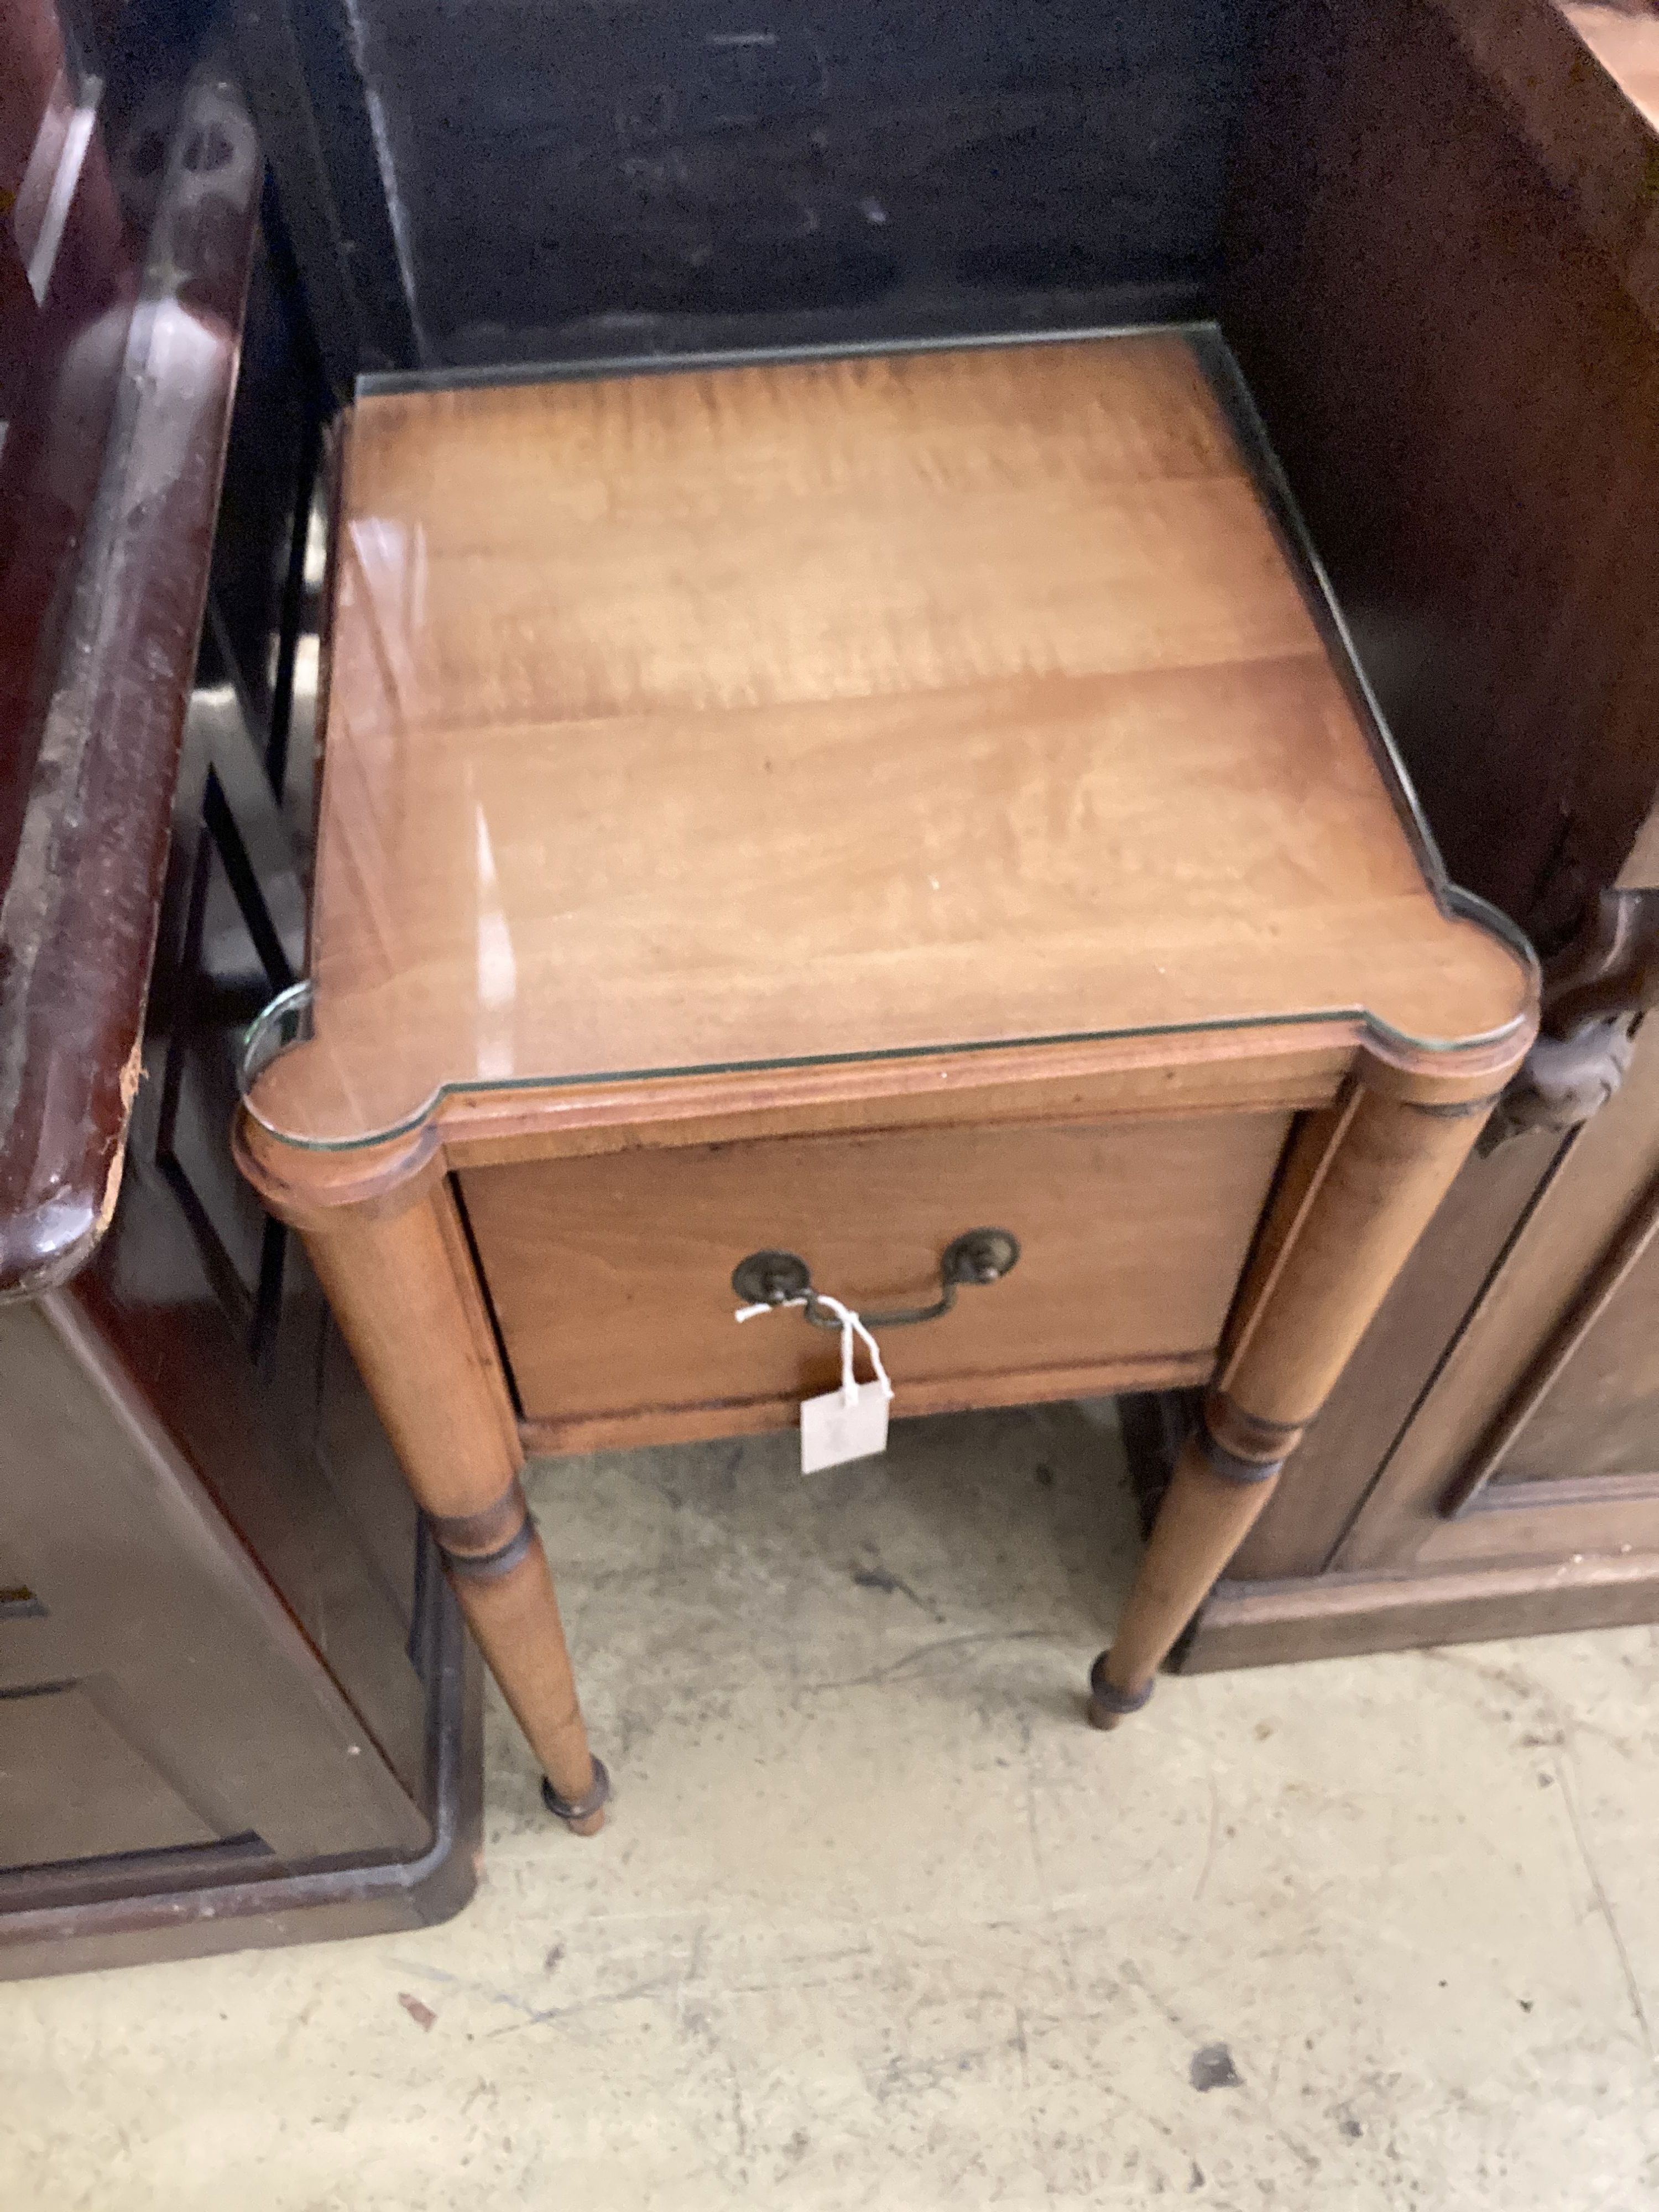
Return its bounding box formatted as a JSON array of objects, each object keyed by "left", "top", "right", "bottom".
[{"left": 462, "top": 1113, "right": 1290, "bottom": 1449}]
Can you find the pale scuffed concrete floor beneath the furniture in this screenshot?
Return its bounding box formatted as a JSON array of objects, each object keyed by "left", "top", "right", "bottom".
[{"left": 0, "top": 1407, "right": 1659, "bottom": 2212}]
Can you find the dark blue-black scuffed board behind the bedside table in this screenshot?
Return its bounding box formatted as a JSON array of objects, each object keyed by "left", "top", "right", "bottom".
[{"left": 243, "top": 0, "right": 1256, "bottom": 367}]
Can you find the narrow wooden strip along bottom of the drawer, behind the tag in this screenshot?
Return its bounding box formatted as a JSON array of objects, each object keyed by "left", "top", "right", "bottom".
[{"left": 518, "top": 1352, "right": 1214, "bottom": 1458}]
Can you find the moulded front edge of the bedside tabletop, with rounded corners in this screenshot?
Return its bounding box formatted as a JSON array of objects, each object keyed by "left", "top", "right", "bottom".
[{"left": 234, "top": 991, "right": 1537, "bottom": 1228}]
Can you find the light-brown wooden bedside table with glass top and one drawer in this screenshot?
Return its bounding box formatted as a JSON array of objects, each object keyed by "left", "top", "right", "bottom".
[{"left": 237, "top": 327, "right": 1535, "bottom": 1832}]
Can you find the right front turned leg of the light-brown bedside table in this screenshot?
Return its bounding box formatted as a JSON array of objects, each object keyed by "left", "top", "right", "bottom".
[{"left": 1088, "top": 1084, "right": 1491, "bottom": 1728}]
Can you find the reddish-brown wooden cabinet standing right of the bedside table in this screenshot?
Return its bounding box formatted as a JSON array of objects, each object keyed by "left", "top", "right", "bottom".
[{"left": 1159, "top": 0, "right": 1659, "bottom": 1668}]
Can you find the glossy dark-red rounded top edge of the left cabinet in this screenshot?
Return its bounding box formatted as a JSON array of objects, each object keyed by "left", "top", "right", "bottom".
[{"left": 0, "top": 78, "right": 263, "bottom": 1296}]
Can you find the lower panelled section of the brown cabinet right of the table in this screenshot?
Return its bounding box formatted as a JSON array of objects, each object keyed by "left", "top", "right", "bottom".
[{"left": 1177, "top": 1024, "right": 1659, "bottom": 1670}]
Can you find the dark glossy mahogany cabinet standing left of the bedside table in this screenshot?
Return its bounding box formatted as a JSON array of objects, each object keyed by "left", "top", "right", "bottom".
[{"left": 0, "top": 4, "right": 480, "bottom": 1978}]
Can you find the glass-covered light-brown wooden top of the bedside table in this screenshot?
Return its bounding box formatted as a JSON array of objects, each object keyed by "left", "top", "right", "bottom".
[{"left": 254, "top": 334, "right": 1528, "bottom": 1144}]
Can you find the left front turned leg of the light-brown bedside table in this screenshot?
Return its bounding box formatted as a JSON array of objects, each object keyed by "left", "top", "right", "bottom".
[{"left": 303, "top": 1181, "right": 611, "bottom": 1836}]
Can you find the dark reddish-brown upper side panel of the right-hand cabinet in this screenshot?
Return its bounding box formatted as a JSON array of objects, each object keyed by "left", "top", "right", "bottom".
[{"left": 1223, "top": 0, "right": 1659, "bottom": 933}]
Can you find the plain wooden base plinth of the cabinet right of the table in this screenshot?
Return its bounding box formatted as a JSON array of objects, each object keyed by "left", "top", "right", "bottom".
[{"left": 1179, "top": 1553, "right": 1659, "bottom": 1674}]
